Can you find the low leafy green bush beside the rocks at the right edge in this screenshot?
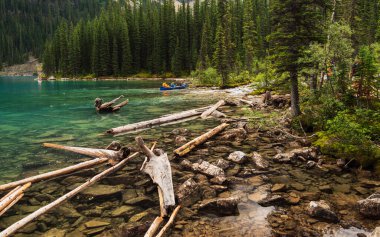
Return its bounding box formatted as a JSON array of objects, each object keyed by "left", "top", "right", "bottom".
[{"left": 315, "top": 111, "right": 380, "bottom": 167}]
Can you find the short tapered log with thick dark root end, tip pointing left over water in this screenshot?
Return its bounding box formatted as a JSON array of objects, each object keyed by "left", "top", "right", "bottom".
[{"left": 43, "top": 143, "right": 130, "bottom": 161}]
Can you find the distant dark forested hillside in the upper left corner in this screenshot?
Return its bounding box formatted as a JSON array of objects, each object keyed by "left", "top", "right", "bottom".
[{"left": 0, "top": 0, "right": 105, "bottom": 67}]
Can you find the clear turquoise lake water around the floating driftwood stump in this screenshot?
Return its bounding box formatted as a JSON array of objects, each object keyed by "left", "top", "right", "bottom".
[{"left": 0, "top": 77, "right": 211, "bottom": 183}]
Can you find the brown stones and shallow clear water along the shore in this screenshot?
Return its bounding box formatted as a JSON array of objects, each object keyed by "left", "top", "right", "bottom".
[{"left": 0, "top": 93, "right": 380, "bottom": 237}]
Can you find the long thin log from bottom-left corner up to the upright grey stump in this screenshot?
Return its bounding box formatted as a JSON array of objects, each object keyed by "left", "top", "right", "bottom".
[{"left": 0, "top": 152, "right": 139, "bottom": 237}]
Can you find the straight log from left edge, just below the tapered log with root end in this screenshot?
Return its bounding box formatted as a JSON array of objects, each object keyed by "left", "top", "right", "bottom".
[{"left": 0, "top": 158, "right": 108, "bottom": 191}]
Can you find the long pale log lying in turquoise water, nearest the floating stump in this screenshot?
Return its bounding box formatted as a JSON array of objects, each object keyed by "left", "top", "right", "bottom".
[{"left": 106, "top": 107, "right": 209, "bottom": 135}]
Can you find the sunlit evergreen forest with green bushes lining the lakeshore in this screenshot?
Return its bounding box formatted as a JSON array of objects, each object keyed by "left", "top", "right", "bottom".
[{"left": 43, "top": 0, "right": 380, "bottom": 170}]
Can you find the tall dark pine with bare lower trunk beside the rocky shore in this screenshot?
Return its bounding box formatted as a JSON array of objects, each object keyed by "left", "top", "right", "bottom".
[{"left": 271, "top": 0, "right": 324, "bottom": 116}]
